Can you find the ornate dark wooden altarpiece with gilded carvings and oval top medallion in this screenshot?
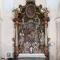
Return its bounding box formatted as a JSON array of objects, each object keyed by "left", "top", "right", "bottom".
[{"left": 13, "top": 0, "right": 49, "bottom": 59}]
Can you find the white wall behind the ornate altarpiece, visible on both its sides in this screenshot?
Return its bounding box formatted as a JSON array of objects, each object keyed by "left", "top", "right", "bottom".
[{"left": 1, "top": 0, "right": 59, "bottom": 60}]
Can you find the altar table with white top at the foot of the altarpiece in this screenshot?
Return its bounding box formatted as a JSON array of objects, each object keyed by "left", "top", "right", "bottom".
[{"left": 18, "top": 53, "right": 46, "bottom": 60}]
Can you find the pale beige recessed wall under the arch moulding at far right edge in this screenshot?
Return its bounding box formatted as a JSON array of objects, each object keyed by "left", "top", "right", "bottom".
[{"left": 56, "top": 18, "right": 60, "bottom": 60}]
